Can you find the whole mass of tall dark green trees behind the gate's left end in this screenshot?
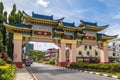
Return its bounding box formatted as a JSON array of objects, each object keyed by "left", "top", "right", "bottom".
[{"left": 0, "top": 2, "right": 23, "bottom": 58}]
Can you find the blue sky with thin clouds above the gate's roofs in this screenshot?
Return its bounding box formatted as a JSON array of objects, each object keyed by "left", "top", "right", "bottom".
[{"left": 0, "top": 0, "right": 120, "bottom": 50}]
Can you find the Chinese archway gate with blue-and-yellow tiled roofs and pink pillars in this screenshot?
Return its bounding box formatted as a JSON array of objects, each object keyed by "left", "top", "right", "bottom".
[{"left": 4, "top": 12, "right": 116, "bottom": 68}]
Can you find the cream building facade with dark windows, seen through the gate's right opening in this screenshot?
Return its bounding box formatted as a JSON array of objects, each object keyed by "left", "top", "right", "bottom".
[{"left": 76, "top": 45, "right": 100, "bottom": 63}]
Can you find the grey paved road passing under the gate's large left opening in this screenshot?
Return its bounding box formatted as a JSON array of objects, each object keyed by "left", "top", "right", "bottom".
[{"left": 27, "top": 63, "right": 116, "bottom": 80}]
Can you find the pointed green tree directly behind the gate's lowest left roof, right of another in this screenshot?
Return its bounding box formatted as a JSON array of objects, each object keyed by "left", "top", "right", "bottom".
[{"left": 7, "top": 4, "right": 23, "bottom": 58}]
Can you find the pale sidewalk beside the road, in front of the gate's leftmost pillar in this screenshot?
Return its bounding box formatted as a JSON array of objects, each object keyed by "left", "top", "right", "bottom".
[{"left": 14, "top": 68, "right": 34, "bottom": 80}]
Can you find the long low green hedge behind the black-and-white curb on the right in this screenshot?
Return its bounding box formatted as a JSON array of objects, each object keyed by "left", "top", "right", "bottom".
[{"left": 70, "top": 62, "right": 120, "bottom": 72}]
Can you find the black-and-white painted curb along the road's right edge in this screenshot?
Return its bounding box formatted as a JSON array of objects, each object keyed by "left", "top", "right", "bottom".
[{"left": 62, "top": 67, "right": 120, "bottom": 79}]
